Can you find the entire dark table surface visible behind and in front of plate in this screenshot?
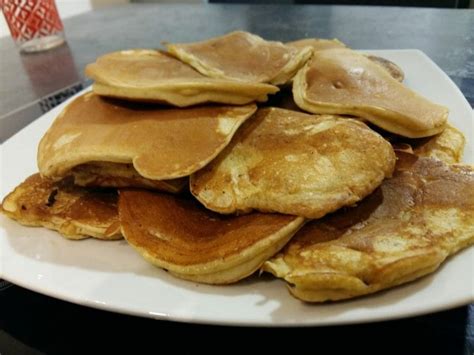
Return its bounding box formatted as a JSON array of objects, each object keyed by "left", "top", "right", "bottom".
[{"left": 0, "top": 4, "right": 474, "bottom": 355}]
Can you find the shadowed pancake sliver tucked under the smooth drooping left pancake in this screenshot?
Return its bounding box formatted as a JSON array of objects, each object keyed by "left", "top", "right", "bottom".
[{"left": 70, "top": 162, "right": 189, "bottom": 193}]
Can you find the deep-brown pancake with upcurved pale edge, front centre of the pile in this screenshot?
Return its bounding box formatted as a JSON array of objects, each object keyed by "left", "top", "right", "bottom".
[{"left": 119, "top": 190, "right": 304, "bottom": 284}]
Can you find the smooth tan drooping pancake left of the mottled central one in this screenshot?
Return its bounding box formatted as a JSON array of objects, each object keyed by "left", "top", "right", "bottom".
[{"left": 38, "top": 92, "right": 256, "bottom": 180}]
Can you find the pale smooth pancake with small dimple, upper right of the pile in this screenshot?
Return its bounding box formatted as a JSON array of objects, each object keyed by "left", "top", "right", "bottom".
[{"left": 293, "top": 48, "right": 448, "bottom": 138}]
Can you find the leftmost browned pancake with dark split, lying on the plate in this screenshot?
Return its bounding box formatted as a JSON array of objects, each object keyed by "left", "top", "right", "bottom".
[{"left": 0, "top": 174, "right": 122, "bottom": 240}]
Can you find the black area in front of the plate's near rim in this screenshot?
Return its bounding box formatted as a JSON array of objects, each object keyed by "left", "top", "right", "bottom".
[{"left": 0, "top": 285, "right": 474, "bottom": 355}]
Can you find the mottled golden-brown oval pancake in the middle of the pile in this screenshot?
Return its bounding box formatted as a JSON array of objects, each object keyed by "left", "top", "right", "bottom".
[{"left": 190, "top": 108, "right": 395, "bottom": 218}]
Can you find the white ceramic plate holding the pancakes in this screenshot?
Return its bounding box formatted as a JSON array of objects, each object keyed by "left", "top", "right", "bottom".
[{"left": 0, "top": 50, "right": 474, "bottom": 326}]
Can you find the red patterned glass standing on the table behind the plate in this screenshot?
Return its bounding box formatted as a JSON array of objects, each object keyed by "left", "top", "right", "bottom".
[{"left": 0, "top": 0, "right": 64, "bottom": 52}]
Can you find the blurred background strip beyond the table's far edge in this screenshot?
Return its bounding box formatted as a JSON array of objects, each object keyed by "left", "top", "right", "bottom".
[{"left": 0, "top": 0, "right": 474, "bottom": 37}]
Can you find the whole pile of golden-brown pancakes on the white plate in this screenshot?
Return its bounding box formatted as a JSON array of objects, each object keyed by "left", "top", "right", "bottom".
[{"left": 1, "top": 32, "right": 474, "bottom": 302}]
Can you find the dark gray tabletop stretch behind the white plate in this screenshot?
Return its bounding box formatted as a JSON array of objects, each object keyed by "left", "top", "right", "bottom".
[{"left": 0, "top": 4, "right": 474, "bottom": 125}]
